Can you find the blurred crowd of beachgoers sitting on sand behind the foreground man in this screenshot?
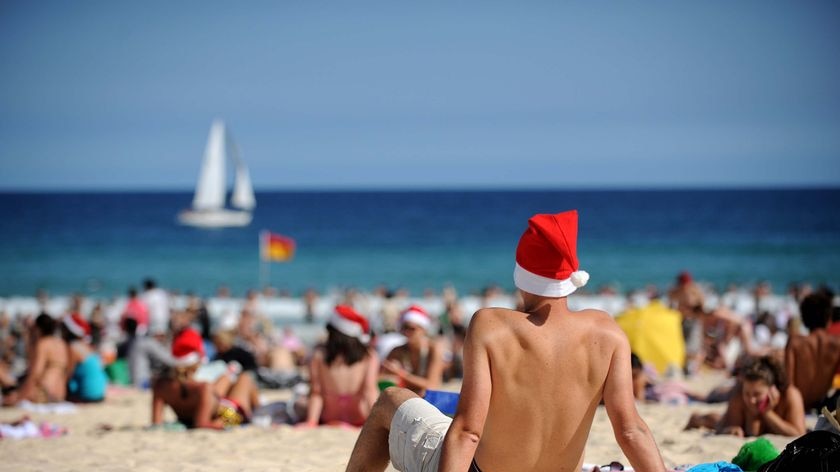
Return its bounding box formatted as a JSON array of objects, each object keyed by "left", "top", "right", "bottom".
[{"left": 0, "top": 273, "right": 840, "bottom": 446}]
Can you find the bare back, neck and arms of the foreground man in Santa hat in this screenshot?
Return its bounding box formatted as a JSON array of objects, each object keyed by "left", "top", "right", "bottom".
[{"left": 441, "top": 293, "right": 662, "bottom": 472}]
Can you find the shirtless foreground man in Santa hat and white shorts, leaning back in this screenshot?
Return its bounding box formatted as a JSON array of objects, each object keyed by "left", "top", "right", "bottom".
[{"left": 347, "top": 211, "right": 665, "bottom": 472}]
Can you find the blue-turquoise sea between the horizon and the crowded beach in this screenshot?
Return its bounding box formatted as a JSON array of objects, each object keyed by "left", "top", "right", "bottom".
[{"left": 0, "top": 189, "right": 840, "bottom": 297}]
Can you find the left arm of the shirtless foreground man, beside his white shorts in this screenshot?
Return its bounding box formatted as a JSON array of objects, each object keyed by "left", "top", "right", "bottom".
[{"left": 438, "top": 311, "right": 492, "bottom": 472}]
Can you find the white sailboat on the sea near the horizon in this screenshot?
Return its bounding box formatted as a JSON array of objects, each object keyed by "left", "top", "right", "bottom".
[{"left": 178, "top": 120, "right": 257, "bottom": 228}]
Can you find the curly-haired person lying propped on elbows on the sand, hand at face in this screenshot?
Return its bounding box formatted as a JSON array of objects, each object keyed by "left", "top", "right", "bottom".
[{"left": 686, "top": 356, "right": 805, "bottom": 437}]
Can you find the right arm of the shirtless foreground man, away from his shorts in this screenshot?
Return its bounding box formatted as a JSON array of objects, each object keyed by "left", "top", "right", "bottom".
[{"left": 604, "top": 333, "right": 665, "bottom": 471}]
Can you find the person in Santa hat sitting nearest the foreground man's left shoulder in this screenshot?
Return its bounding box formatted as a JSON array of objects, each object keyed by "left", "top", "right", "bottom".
[{"left": 382, "top": 305, "right": 446, "bottom": 396}]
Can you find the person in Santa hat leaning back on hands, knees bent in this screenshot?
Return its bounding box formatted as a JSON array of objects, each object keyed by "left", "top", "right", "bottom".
[{"left": 152, "top": 328, "right": 259, "bottom": 429}]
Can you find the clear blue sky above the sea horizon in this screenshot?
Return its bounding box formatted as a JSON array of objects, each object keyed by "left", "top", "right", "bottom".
[{"left": 0, "top": 0, "right": 840, "bottom": 193}]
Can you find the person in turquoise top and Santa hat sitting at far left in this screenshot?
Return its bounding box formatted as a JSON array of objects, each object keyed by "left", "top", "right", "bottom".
[{"left": 61, "top": 312, "right": 108, "bottom": 402}]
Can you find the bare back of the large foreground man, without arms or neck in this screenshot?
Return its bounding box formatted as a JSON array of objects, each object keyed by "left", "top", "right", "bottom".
[{"left": 467, "top": 305, "right": 619, "bottom": 471}]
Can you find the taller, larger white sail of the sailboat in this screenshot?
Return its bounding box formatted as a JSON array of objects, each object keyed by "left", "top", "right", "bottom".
[{"left": 193, "top": 120, "right": 227, "bottom": 210}]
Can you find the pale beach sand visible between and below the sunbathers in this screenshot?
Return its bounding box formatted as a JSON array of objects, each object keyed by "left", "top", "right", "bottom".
[{"left": 0, "top": 374, "right": 800, "bottom": 472}]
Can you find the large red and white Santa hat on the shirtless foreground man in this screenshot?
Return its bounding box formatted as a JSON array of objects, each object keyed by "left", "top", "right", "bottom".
[{"left": 513, "top": 210, "right": 589, "bottom": 297}]
